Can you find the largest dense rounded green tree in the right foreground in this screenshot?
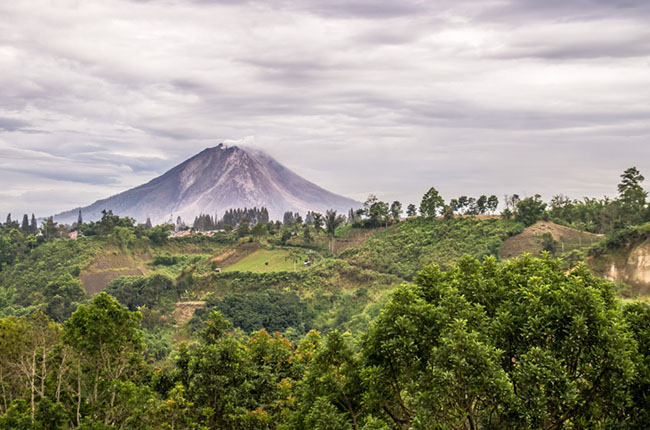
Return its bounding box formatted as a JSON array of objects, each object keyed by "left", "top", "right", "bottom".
[{"left": 362, "top": 256, "right": 635, "bottom": 429}]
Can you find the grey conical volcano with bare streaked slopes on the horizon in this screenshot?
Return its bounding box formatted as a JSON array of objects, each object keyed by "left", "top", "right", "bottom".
[{"left": 54, "top": 144, "right": 362, "bottom": 224}]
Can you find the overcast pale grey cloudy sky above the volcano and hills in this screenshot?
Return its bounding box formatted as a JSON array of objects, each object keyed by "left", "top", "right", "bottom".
[{"left": 0, "top": 0, "right": 650, "bottom": 218}]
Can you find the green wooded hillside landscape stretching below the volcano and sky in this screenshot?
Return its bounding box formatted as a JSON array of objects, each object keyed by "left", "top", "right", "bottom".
[{"left": 0, "top": 168, "right": 650, "bottom": 430}]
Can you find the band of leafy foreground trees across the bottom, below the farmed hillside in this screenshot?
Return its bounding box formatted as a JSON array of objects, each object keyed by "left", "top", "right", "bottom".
[{"left": 0, "top": 257, "right": 650, "bottom": 430}]
